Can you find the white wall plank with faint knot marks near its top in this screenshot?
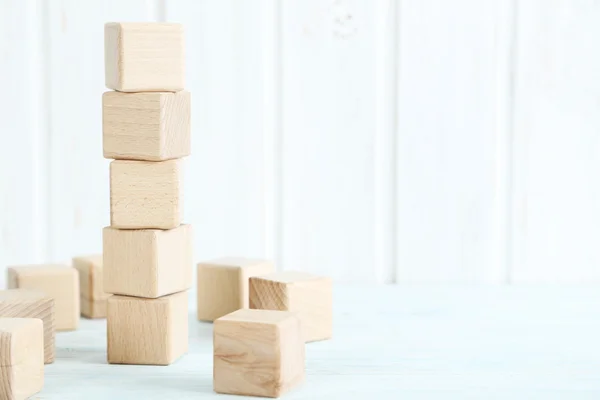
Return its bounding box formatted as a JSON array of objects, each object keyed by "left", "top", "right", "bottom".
[{"left": 281, "top": 0, "right": 390, "bottom": 282}]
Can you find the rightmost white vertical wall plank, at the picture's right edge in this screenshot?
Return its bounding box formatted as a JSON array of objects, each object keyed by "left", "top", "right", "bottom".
[{"left": 512, "top": 0, "right": 600, "bottom": 283}]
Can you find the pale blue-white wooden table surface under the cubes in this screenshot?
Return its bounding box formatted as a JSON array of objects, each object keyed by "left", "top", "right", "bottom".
[{"left": 42, "top": 285, "right": 600, "bottom": 400}]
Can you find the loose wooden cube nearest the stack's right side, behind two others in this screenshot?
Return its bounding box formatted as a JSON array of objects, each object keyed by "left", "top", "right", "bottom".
[{"left": 197, "top": 257, "right": 275, "bottom": 321}]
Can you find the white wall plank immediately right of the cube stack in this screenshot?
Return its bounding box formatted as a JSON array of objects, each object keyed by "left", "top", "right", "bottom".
[{"left": 166, "top": 0, "right": 268, "bottom": 260}]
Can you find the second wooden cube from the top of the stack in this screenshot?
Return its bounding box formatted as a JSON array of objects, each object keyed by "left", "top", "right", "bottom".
[{"left": 102, "top": 91, "right": 191, "bottom": 161}]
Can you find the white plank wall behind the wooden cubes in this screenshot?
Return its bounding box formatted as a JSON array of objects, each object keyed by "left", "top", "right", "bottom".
[{"left": 0, "top": 0, "right": 600, "bottom": 284}]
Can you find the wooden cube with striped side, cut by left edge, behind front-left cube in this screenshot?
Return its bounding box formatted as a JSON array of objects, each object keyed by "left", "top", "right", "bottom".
[{"left": 0, "top": 289, "right": 56, "bottom": 364}]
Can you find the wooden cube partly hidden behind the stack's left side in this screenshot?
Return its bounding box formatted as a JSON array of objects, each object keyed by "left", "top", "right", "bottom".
[{"left": 73, "top": 254, "right": 110, "bottom": 318}]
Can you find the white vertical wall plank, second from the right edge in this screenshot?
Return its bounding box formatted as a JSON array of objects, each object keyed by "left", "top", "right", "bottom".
[{"left": 397, "top": 0, "right": 508, "bottom": 282}]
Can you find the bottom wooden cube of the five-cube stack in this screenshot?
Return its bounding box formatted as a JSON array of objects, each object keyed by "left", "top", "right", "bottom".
[{"left": 107, "top": 292, "right": 188, "bottom": 365}]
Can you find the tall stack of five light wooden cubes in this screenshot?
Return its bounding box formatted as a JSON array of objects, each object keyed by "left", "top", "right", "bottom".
[{"left": 102, "top": 23, "right": 193, "bottom": 365}]
